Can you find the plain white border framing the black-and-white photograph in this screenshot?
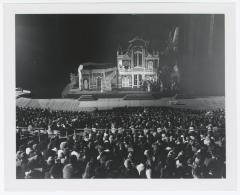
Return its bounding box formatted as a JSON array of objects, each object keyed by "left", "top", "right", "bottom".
[{"left": 3, "top": 2, "right": 237, "bottom": 191}]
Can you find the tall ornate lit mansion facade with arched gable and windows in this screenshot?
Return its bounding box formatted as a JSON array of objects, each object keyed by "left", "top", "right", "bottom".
[{"left": 117, "top": 37, "right": 159, "bottom": 88}]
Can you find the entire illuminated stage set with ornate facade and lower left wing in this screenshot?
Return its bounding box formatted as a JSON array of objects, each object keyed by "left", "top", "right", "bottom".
[{"left": 62, "top": 35, "right": 179, "bottom": 100}]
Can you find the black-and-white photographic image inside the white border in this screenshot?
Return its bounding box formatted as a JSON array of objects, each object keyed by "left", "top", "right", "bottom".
[{"left": 15, "top": 14, "right": 227, "bottom": 180}]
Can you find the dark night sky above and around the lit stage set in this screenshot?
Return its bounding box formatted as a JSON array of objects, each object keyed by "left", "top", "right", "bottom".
[{"left": 16, "top": 14, "right": 225, "bottom": 98}]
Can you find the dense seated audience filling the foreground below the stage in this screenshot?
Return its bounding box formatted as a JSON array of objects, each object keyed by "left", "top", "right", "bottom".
[{"left": 16, "top": 107, "right": 226, "bottom": 179}]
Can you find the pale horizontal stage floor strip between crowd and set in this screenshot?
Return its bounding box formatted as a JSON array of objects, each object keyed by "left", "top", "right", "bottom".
[{"left": 16, "top": 96, "right": 225, "bottom": 111}]
